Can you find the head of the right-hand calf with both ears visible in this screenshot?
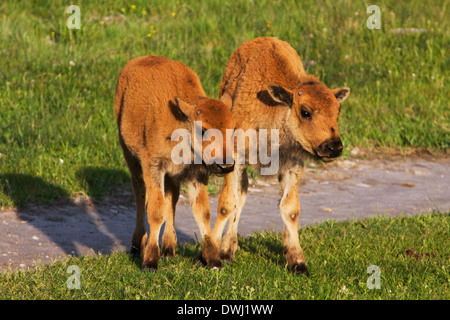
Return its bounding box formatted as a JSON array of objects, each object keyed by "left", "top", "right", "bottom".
[{"left": 267, "top": 80, "right": 350, "bottom": 162}]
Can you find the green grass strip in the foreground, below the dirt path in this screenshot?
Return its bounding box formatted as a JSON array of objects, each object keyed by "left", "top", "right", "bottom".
[{"left": 0, "top": 213, "right": 450, "bottom": 300}]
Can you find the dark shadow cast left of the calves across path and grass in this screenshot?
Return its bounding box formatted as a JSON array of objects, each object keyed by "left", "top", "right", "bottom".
[{"left": 0, "top": 167, "right": 195, "bottom": 263}]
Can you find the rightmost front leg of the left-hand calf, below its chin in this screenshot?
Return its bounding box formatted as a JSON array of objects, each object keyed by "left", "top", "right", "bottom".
[{"left": 188, "top": 181, "right": 222, "bottom": 268}]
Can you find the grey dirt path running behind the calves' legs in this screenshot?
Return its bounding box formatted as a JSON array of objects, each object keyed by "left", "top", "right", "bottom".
[{"left": 0, "top": 158, "right": 450, "bottom": 271}]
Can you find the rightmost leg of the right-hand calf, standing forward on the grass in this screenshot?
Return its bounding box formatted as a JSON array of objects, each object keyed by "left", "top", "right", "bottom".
[{"left": 280, "top": 166, "right": 308, "bottom": 274}]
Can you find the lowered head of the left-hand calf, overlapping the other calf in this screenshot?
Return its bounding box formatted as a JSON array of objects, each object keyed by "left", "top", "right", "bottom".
[{"left": 175, "top": 97, "right": 236, "bottom": 174}]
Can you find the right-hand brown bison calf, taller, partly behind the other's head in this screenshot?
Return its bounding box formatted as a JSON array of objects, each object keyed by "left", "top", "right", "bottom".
[{"left": 212, "top": 38, "right": 350, "bottom": 274}]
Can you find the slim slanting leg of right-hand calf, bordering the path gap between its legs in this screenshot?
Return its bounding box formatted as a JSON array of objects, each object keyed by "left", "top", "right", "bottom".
[{"left": 220, "top": 167, "right": 248, "bottom": 262}]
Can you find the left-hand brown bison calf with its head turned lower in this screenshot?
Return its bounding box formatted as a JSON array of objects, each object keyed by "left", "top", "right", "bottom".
[{"left": 114, "top": 56, "right": 235, "bottom": 269}]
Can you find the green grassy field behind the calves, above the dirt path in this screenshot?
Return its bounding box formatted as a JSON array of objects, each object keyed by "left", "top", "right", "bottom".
[{"left": 0, "top": 0, "right": 450, "bottom": 206}]
